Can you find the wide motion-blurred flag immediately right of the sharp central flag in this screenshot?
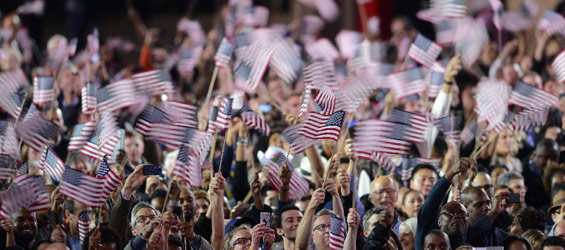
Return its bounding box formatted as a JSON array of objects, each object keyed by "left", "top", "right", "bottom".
[{"left": 354, "top": 119, "right": 411, "bottom": 155}]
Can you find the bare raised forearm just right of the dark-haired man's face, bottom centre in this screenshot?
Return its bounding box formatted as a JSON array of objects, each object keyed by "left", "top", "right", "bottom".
[{"left": 295, "top": 188, "right": 326, "bottom": 250}]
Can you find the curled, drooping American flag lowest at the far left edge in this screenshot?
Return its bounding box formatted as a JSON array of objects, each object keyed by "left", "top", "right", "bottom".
[{"left": 13, "top": 174, "right": 51, "bottom": 212}]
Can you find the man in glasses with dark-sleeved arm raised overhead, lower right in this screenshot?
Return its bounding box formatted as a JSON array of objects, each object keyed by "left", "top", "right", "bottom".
[{"left": 415, "top": 158, "right": 474, "bottom": 249}]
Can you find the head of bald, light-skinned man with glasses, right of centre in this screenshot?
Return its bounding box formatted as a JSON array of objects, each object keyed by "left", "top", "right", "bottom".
[{"left": 369, "top": 176, "right": 401, "bottom": 234}]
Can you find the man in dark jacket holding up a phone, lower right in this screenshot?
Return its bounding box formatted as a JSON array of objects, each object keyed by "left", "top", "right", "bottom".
[{"left": 461, "top": 187, "right": 509, "bottom": 247}]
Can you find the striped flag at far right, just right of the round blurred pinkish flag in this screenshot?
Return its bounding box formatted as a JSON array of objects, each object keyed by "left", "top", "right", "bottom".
[{"left": 509, "top": 82, "right": 559, "bottom": 109}]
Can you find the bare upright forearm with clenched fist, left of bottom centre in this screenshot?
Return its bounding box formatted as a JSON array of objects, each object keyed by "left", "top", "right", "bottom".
[{"left": 208, "top": 173, "right": 226, "bottom": 249}]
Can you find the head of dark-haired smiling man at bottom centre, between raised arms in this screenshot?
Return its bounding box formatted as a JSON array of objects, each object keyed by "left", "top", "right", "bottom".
[{"left": 276, "top": 205, "right": 303, "bottom": 250}]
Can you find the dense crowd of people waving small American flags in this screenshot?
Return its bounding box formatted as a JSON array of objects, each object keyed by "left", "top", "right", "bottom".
[{"left": 5, "top": 0, "right": 565, "bottom": 250}]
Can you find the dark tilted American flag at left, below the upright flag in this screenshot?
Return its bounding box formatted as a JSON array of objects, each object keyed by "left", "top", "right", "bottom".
[{"left": 16, "top": 113, "right": 61, "bottom": 152}]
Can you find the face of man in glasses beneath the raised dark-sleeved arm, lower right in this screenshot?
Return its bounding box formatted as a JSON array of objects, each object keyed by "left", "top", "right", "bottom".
[{"left": 438, "top": 202, "right": 469, "bottom": 237}]
